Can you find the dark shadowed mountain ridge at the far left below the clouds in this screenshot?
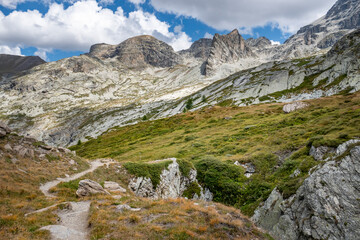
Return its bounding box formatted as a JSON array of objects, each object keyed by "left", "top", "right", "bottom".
[{"left": 0, "top": 54, "right": 45, "bottom": 74}]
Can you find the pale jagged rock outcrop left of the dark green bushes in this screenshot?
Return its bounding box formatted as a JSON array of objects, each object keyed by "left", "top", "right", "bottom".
[{"left": 129, "top": 159, "right": 212, "bottom": 201}]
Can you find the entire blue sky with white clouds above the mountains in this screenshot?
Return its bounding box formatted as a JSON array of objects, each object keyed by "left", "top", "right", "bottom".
[{"left": 0, "top": 0, "right": 336, "bottom": 61}]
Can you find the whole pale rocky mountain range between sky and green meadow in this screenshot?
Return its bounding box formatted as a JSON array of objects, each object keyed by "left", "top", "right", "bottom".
[{"left": 0, "top": 1, "right": 359, "bottom": 146}]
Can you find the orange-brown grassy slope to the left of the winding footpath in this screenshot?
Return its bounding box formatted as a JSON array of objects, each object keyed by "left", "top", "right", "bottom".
[{"left": 0, "top": 135, "right": 88, "bottom": 239}]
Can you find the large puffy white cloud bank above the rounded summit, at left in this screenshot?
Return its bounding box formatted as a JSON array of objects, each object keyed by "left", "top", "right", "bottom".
[{"left": 0, "top": 0, "right": 191, "bottom": 51}]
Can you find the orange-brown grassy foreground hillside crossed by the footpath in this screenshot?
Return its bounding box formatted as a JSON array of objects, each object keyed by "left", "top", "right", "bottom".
[{"left": 0, "top": 124, "right": 269, "bottom": 240}]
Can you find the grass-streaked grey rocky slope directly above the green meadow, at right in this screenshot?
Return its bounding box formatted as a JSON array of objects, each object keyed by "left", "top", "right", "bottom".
[{"left": 159, "top": 30, "right": 360, "bottom": 116}]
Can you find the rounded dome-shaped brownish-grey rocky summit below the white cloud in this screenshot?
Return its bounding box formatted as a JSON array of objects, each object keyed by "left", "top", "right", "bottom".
[{"left": 89, "top": 35, "right": 180, "bottom": 68}]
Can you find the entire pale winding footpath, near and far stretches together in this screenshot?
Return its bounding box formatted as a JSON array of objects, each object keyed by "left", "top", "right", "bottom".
[{"left": 34, "top": 159, "right": 114, "bottom": 240}]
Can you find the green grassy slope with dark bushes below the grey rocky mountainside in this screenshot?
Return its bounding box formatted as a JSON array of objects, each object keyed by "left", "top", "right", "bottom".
[{"left": 73, "top": 93, "right": 360, "bottom": 215}]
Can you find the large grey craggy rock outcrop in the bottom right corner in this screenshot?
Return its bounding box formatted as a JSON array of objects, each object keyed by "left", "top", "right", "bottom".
[{"left": 252, "top": 140, "right": 360, "bottom": 240}]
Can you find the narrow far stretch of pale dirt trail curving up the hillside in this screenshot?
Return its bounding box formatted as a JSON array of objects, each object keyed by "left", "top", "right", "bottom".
[{"left": 40, "top": 159, "right": 114, "bottom": 197}]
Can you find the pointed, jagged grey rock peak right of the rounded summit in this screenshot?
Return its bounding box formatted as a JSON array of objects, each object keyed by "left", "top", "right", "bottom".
[{"left": 205, "top": 30, "right": 255, "bottom": 75}]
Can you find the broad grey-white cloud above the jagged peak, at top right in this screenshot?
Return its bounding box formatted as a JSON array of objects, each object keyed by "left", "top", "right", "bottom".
[{"left": 151, "top": 0, "right": 336, "bottom": 33}]
